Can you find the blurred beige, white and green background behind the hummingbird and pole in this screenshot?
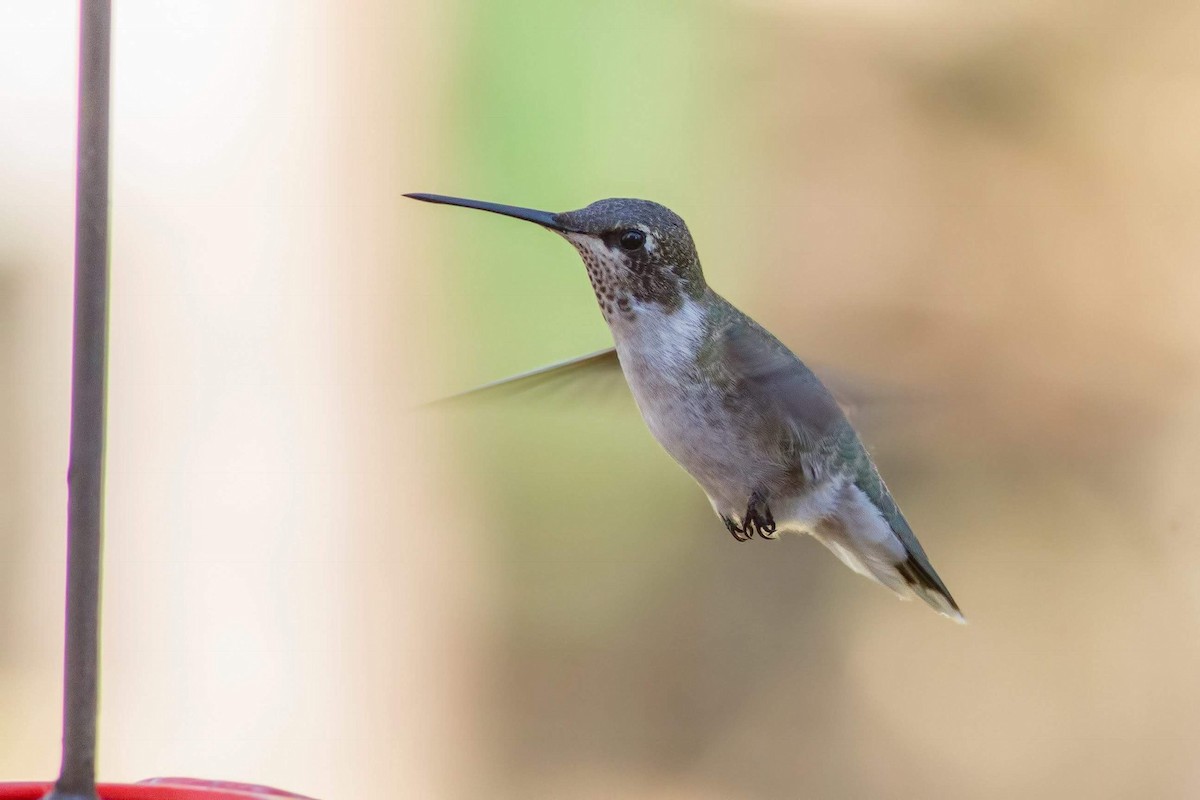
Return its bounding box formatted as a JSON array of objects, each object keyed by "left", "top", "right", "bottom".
[{"left": 0, "top": 0, "right": 1200, "bottom": 800}]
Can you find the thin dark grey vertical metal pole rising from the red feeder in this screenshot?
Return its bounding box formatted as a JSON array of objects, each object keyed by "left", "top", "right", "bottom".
[{"left": 48, "top": 0, "right": 112, "bottom": 800}]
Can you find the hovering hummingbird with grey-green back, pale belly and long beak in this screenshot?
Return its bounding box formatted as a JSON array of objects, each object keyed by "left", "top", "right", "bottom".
[{"left": 406, "top": 194, "right": 966, "bottom": 622}]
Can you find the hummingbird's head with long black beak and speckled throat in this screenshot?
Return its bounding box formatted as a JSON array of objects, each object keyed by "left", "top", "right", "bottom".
[{"left": 407, "top": 194, "right": 706, "bottom": 321}]
